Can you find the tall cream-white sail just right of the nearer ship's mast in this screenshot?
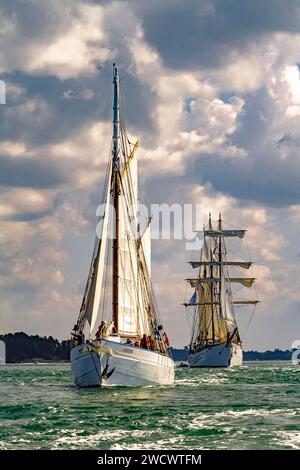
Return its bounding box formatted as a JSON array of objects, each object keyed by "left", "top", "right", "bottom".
[{"left": 118, "top": 153, "right": 138, "bottom": 336}]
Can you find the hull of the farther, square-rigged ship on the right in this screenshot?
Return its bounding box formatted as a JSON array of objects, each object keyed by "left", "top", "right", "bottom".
[{"left": 188, "top": 344, "right": 243, "bottom": 367}]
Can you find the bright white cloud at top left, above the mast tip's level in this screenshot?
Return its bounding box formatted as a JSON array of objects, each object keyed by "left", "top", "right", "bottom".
[{"left": 0, "top": 2, "right": 111, "bottom": 80}]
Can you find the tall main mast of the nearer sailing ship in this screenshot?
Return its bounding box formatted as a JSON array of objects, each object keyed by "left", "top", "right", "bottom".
[{"left": 112, "top": 64, "right": 120, "bottom": 333}]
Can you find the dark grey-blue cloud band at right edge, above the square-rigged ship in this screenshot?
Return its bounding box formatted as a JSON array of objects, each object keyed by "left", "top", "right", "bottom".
[{"left": 190, "top": 152, "right": 300, "bottom": 207}]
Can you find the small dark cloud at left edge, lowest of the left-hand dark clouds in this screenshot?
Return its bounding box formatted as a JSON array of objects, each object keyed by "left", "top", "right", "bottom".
[{"left": 0, "top": 156, "right": 67, "bottom": 189}]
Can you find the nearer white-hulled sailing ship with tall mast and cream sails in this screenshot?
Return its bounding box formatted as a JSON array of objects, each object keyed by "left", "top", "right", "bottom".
[{"left": 71, "top": 64, "right": 174, "bottom": 387}]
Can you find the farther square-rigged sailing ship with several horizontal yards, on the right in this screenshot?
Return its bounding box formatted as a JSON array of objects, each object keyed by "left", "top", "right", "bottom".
[{"left": 184, "top": 214, "right": 258, "bottom": 367}]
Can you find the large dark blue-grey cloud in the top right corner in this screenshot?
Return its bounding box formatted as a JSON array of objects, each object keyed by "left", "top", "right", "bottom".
[{"left": 136, "top": 0, "right": 300, "bottom": 69}]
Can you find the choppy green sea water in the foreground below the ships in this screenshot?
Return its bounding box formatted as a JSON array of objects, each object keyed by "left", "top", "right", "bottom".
[{"left": 0, "top": 362, "right": 300, "bottom": 450}]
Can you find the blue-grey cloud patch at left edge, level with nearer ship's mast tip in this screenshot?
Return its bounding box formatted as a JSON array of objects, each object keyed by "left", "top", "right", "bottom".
[{"left": 0, "top": 73, "right": 111, "bottom": 146}]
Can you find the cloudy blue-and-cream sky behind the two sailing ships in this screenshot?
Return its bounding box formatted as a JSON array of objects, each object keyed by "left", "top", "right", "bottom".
[{"left": 0, "top": 0, "right": 300, "bottom": 350}]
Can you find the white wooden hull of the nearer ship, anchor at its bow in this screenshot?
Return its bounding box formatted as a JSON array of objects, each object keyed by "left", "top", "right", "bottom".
[{"left": 71, "top": 340, "right": 174, "bottom": 387}]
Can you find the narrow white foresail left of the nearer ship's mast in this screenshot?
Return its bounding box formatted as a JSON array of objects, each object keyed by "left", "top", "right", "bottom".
[{"left": 89, "top": 165, "right": 112, "bottom": 331}]
